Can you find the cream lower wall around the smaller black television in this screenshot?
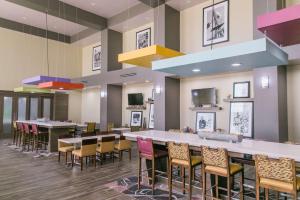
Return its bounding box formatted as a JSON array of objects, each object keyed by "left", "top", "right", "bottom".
[{"left": 122, "top": 83, "right": 153, "bottom": 126}]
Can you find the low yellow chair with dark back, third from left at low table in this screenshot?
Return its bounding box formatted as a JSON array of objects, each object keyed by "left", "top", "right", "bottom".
[{"left": 96, "top": 136, "right": 116, "bottom": 165}]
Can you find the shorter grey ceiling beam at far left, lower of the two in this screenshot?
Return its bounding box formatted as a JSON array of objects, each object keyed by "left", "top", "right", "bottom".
[{"left": 0, "top": 18, "right": 71, "bottom": 43}]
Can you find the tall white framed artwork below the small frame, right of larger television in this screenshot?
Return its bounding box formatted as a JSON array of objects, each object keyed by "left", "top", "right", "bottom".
[{"left": 229, "top": 102, "right": 253, "bottom": 138}]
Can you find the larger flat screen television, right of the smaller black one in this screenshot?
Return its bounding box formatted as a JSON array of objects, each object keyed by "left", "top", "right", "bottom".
[{"left": 192, "top": 88, "right": 217, "bottom": 107}]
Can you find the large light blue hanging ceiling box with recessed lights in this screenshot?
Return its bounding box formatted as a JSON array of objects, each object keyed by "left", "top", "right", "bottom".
[{"left": 152, "top": 38, "right": 288, "bottom": 77}]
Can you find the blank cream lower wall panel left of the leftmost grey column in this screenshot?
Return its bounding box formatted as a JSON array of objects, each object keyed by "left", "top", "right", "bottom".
[{"left": 81, "top": 87, "right": 100, "bottom": 123}]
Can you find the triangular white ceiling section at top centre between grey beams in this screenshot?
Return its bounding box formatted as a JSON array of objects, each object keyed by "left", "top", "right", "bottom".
[{"left": 61, "top": 0, "right": 140, "bottom": 18}]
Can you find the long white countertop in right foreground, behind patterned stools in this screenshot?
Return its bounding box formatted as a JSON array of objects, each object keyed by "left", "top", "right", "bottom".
[{"left": 123, "top": 130, "right": 300, "bottom": 162}]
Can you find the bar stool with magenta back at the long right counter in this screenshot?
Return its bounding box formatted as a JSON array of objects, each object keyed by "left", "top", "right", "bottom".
[{"left": 137, "top": 137, "right": 168, "bottom": 194}]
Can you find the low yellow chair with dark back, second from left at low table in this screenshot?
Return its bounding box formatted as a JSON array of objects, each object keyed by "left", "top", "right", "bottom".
[{"left": 72, "top": 138, "right": 97, "bottom": 171}]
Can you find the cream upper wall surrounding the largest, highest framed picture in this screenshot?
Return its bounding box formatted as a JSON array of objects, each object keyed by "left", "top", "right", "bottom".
[{"left": 180, "top": 0, "right": 253, "bottom": 53}]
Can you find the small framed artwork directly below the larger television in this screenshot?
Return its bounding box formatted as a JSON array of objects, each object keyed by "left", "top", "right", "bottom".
[{"left": 196, "top": 112, "right": 216, "bottom": 132}]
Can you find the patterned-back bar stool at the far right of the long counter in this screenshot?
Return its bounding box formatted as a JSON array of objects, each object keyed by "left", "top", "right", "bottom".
[{"left": 255, "top": 155, "right": 300, "bottom": 200}]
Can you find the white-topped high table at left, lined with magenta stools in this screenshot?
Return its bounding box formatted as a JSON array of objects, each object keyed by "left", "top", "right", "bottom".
[{"left": 17, "top": 120, "right": 77, "bottom": 152}]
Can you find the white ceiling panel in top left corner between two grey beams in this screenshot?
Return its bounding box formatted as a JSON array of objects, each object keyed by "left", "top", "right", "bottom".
[{"left": 0, "top": 0, "right": 87, "bottom": 35}]
